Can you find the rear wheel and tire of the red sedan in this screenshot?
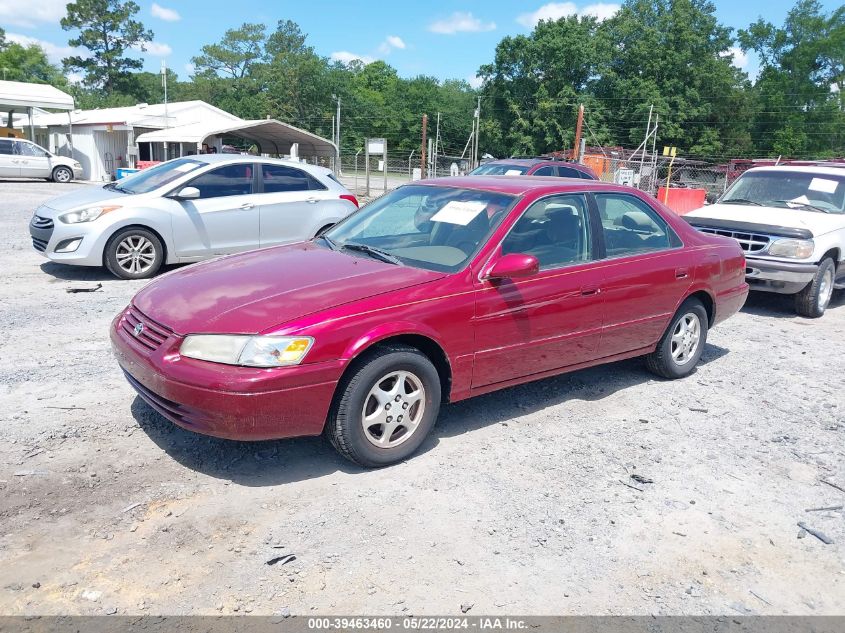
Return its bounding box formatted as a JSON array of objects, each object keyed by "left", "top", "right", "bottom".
[{"left": 646, "top": 297, "right": 708, "bottom": 380}]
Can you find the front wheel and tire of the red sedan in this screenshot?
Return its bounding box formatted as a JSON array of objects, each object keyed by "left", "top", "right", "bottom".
[{"left": 325, "top": 345, "right": 441, "bottom": 468}]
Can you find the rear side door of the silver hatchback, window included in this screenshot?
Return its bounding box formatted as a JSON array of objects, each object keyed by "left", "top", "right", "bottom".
[{"left": 256, "top": 163, "right": 332, "bottom": 247}]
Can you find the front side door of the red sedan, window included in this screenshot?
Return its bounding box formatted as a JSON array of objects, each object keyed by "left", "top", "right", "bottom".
[{"left": 472, "top": 194, "right": 603, "bottom": 388}]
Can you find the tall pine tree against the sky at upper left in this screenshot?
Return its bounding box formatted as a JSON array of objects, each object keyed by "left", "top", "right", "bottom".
[{"left": 61, "top": 0, "right": 153, "bottom": 95}]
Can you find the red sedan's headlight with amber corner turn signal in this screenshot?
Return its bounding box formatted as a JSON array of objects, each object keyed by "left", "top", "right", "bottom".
[{"left": 179, "top": 334, "right": 314, "bottom": 367}]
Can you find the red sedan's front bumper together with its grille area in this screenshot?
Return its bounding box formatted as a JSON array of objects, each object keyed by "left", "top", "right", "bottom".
[{"left": 111, "top": 307, "right": 343, "bottom": 440}]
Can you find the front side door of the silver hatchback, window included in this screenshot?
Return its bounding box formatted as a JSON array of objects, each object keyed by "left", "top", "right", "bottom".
[{"left": 168, "top": 163, "right": 259, "bottom": 259}]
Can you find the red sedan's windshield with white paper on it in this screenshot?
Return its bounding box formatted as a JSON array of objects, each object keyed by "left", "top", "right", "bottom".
[{"left": 318, "top": 185, "right": 515, "bottom": 272}]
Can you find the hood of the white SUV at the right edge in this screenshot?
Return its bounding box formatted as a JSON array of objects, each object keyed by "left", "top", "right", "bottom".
[{"left": 685, "top": 204, "right": 845, "bottom": 235}]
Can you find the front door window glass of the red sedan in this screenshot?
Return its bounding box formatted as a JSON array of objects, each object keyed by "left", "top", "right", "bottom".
[{"left": 502, "top": 194, "right": 592, "bottom": 270}]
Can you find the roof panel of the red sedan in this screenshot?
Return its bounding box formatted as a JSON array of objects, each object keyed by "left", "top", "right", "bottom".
[{"left": 410, "top": 176, "right": 635, "bottom": 195}]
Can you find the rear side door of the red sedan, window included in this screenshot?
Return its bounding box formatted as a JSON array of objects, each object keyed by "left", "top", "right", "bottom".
[{"left": 592, "top": 192, "right": 693, "bottom": 358}]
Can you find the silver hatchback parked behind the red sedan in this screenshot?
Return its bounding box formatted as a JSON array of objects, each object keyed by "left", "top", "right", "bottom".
[{"left": 29, "top": 154, "right": 358, "bottom": 279}]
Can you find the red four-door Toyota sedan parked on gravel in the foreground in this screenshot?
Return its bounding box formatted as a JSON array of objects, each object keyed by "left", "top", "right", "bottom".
[{"left": 111, "top": 176, "right": 748, "bottom": 466}]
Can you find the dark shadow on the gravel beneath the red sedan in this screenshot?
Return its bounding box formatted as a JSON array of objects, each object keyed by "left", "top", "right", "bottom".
[{"left": 132, "top": 344, "right": 728, "bottom": 486}]
